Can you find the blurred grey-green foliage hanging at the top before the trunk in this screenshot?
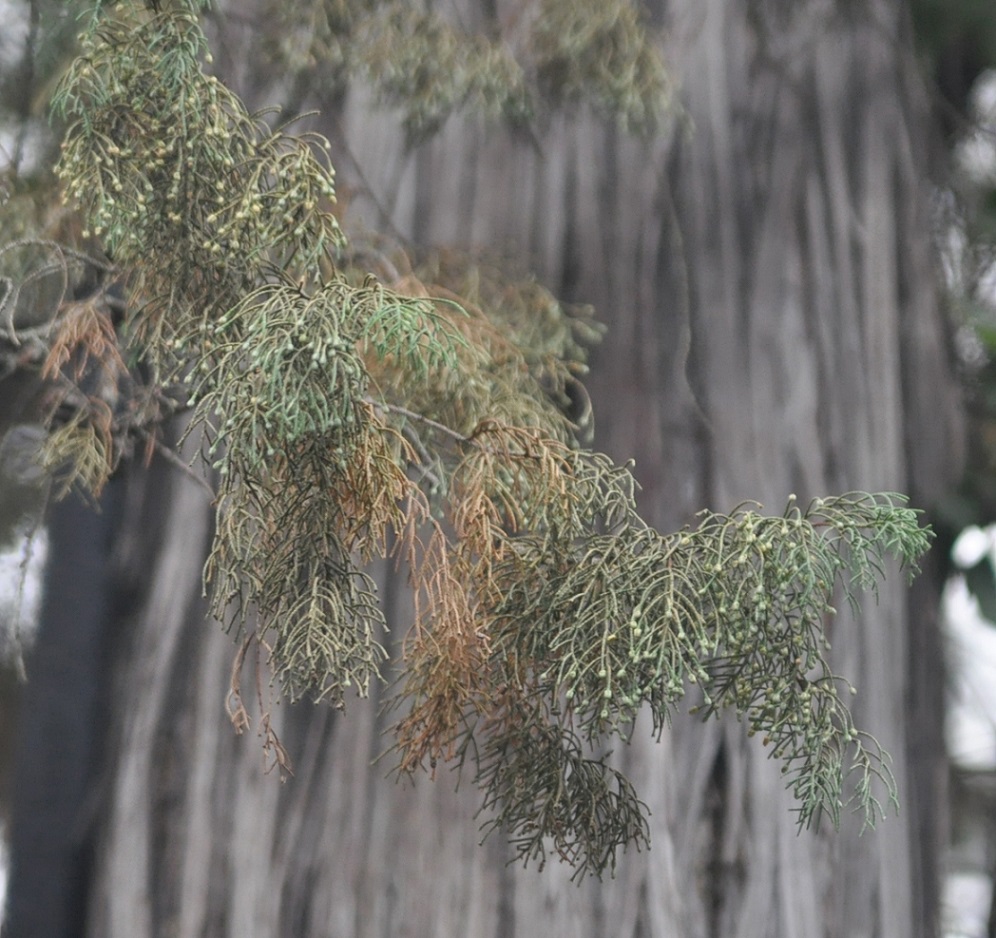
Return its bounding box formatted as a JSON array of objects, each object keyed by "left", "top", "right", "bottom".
[{"left": 260, "top": 0, "right": 673, "bottom": 145}]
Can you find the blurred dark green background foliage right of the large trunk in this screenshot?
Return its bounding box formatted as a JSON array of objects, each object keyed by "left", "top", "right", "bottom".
[{"left": 911, "top": 0, "right": 996, "bottom": 600}]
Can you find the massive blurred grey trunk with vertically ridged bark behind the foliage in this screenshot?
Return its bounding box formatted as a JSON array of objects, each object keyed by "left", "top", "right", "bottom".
[{"left": 9, "top": 0, "right": 961, "bottom": 938}]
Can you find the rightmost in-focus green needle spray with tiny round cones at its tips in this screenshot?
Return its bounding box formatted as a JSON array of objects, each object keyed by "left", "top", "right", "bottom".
[{"left": 493, "top": 494, "right": 929, "bottom": 855}]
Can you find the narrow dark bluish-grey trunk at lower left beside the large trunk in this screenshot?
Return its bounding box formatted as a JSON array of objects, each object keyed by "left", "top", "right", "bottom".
[{"left": 5, "top": 497, "right": 115, "bottom": 938}]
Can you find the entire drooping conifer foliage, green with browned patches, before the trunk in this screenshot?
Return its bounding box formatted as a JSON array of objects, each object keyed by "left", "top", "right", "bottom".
[{"left": 25, "top": 0, "right": 929, "bottom": 876}]
